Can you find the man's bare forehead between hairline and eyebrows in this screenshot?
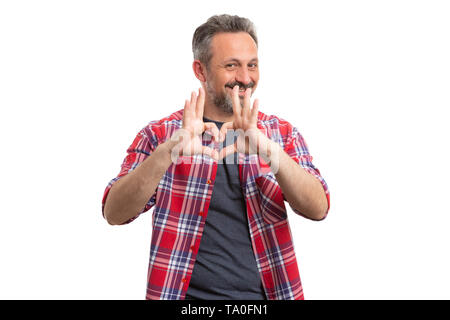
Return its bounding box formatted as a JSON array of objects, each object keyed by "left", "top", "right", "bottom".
[{"left": 211, "top": 32, "right": 258, "bottom": 61}]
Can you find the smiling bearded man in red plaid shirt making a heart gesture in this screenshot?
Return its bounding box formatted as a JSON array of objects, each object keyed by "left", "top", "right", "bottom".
[{"left": 103, "top": 15, "right": 329, "bottom": 299}]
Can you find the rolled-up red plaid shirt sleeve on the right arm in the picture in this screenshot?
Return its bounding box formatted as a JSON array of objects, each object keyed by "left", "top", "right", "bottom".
[{"left": 283, "top": 124, "right": 330, "bottom": 219}]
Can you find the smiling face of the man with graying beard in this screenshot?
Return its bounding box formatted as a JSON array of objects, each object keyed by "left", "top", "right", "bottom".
[{"left": 206, "top": 32, "right": 259, "bottom": 114}]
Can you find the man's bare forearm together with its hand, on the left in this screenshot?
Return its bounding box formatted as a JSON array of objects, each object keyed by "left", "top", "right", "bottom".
[{"left": 104, "top": 89, "right": 219, "bottom": 224}]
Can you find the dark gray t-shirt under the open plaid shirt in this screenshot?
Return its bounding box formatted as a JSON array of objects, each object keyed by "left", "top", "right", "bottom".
[{"left": 186, "top": 118, "right": 266, "bottom": 300}]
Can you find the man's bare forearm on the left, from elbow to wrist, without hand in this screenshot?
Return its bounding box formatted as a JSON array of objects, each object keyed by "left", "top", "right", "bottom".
[{"left": 104, "top": 140, "right": 177, "bottom": 225}]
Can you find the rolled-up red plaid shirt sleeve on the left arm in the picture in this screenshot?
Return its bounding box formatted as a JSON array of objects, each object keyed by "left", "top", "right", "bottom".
[{"left": 102, "top": 128, "right": 158, "bottom": 224}]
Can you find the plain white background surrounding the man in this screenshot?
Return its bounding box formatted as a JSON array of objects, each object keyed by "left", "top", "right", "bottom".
[{"left": 0, "top": 0, "right": 450, "bottom": 299}]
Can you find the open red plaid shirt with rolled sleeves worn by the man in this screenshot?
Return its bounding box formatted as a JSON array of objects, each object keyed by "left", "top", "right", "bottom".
[{"left": 102, "top": 109, "right": 330, "bottom": 300}]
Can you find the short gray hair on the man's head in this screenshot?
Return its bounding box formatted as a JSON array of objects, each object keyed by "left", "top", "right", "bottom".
[{"left": 192, "top": 14, "right": 258, "bottom": 67}]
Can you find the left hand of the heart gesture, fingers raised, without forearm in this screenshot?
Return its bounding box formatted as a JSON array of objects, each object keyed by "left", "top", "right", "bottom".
[{"left": 169, "top": 88, "right": 221, "bottom": 163}]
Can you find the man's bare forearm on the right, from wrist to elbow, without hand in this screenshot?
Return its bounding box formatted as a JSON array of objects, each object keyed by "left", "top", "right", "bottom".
[{"left": 270, "top": 142, "right": 328, "bottom": 220}]
